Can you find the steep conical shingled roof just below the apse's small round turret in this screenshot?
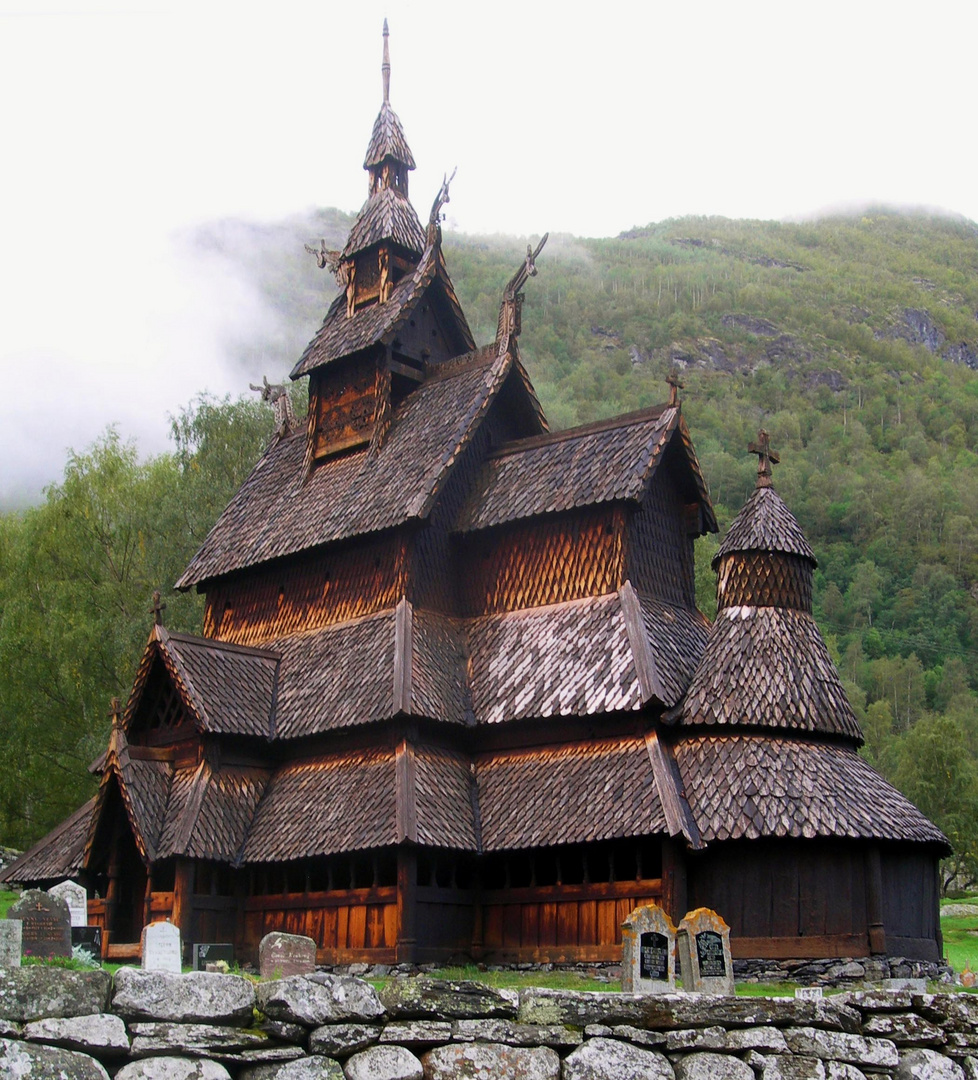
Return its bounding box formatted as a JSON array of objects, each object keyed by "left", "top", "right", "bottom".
[{"left": 682, "top": 607, "right": 862, "bottom": 743}]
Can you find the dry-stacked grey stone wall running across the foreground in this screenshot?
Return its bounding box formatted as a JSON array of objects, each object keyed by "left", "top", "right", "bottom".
[{"left": 0, "top": 967, "right": 978, "bottom": 1080}]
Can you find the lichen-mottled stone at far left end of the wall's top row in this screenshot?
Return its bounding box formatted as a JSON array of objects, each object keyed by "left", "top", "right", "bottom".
[{"left": 0, "top": 964, "right": 112, "bottom": 1023}]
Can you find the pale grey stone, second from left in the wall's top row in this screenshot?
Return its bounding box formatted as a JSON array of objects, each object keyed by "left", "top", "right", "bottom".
[{"left": 112, "top": 968, "right": 255, "bottom": 1024}]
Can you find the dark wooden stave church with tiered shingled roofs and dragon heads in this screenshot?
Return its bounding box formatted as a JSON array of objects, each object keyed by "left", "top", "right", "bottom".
[{"left": 0, "top": 26, "right": 947, "bottom": 963}]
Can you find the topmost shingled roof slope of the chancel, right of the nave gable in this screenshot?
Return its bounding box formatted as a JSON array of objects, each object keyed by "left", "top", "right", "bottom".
[{"left": 458, "top": 407, "right": 705, "bottom": 531}]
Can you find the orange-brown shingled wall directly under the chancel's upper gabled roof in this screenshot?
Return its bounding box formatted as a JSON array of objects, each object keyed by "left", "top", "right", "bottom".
[{"left": 459, "top": 507, "right": 624, "bottom": 616}]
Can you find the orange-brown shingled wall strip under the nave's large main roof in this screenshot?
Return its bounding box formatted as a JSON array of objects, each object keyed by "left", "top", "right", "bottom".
[{"left": 204, "top": 534, "right": 406, "bottom": 645}]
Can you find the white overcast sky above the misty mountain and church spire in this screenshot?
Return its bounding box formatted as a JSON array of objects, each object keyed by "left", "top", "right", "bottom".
[{"left": 0, "top": 0, "right": 978, "bottom": 504}]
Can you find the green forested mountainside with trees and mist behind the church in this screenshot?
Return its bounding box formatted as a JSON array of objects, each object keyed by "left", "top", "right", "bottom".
[{"left": 0, "top": 210, "right": 978, "bottom": 885}]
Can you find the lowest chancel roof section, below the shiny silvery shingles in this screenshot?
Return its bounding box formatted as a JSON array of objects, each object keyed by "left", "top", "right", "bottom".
[{"left": 476, "top": 739, "right": 667, "bottom": 851}]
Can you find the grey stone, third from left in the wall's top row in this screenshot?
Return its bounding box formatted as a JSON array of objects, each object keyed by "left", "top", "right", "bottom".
[{"left": 258, "top": 972, "right": 384, "bottom": 1027}]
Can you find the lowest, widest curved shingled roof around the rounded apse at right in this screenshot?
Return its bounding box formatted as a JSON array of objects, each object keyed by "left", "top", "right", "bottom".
[{"left": 675, "top": 734, "right": 949, "bottom": 850}]
